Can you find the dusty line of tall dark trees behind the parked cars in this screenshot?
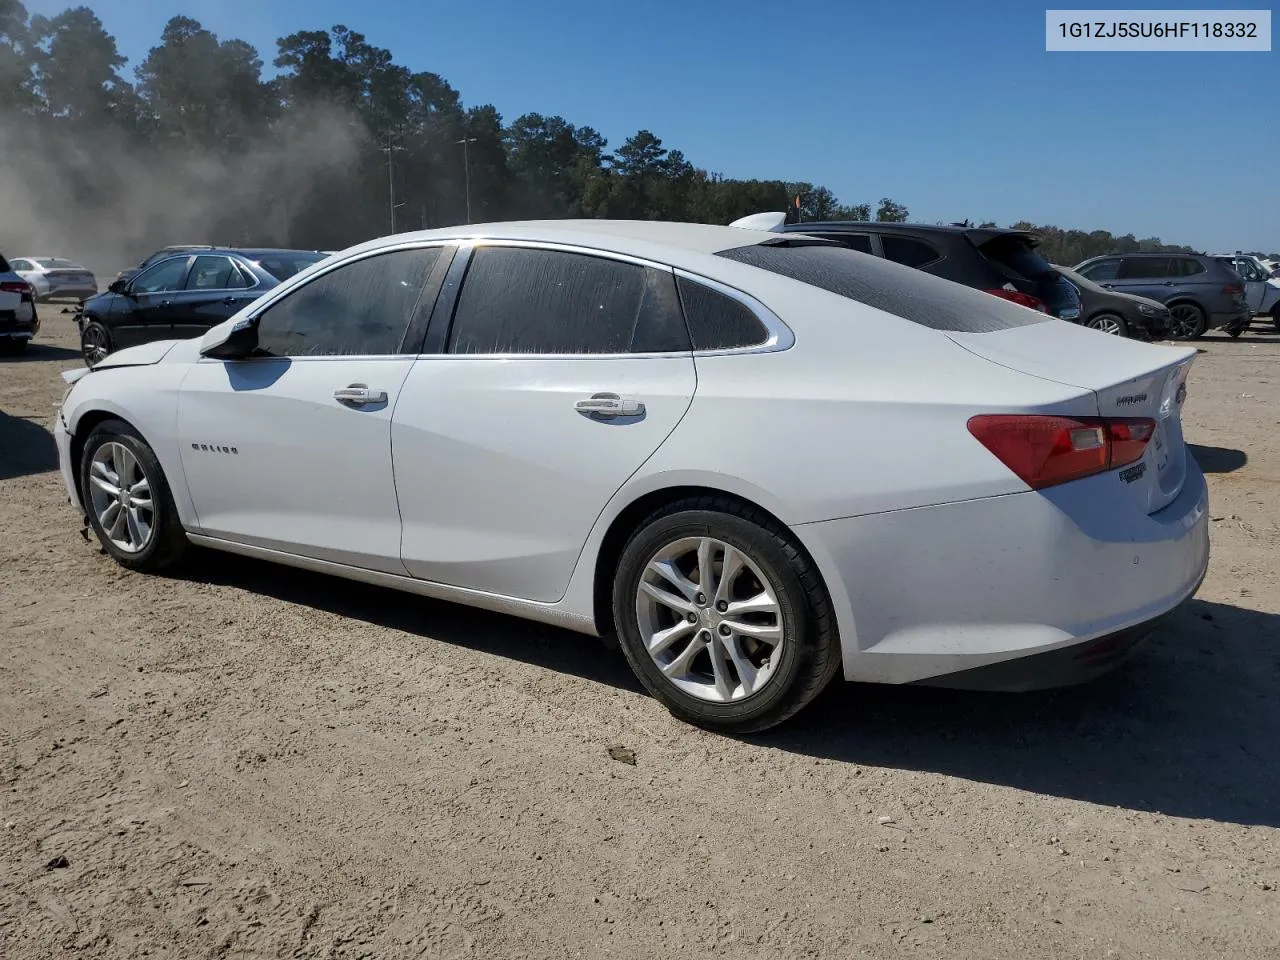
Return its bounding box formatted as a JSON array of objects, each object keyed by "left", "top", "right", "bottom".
[{"left": 0, "top": 0, "right": 1259, "bottom": 262}]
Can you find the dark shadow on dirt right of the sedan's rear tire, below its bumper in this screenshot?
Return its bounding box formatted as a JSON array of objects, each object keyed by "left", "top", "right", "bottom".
[{"left": 763, "top": 600, "right": 1280, "bottom": 827}]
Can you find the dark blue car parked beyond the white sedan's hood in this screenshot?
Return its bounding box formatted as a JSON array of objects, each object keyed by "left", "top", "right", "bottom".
[{"left": 77, "top": 247, "right": 325, "bottom": 366}]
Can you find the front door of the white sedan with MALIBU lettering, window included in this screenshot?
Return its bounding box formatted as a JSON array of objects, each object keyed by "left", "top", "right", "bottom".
[{"left": 178, "top": 246, "right": 447, "bottom": 575}]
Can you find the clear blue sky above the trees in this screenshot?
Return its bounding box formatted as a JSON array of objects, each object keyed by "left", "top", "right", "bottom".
[{"left": 26, "top": 0, "right": 1280, "bottom": 251}]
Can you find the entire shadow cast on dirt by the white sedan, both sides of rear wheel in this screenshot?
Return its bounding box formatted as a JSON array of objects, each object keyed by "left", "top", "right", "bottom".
[{"left": 177, "top": 553, "right": 1280, "bottom": 827}]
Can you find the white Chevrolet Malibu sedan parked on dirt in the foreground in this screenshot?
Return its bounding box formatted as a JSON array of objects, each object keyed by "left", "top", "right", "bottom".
[{"left": 54, "top": 220, "right": 1208, "bottom": 731}]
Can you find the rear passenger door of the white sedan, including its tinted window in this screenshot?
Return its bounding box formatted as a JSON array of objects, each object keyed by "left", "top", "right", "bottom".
[{"left": 392, "top": 242, "right": 695, "bottom": 602}]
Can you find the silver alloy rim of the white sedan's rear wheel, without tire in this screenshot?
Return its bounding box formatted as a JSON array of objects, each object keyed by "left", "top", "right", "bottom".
[{"left": 635, "top": 536, "right": 786, "bottom": 703}]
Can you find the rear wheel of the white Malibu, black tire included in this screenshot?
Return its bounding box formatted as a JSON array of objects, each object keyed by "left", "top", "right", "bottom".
[{"left": 613, "top": 497, "right": 840, "bottom": 733}]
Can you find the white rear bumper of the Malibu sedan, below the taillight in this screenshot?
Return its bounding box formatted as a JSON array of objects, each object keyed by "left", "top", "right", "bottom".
[{"left": 796, "top": 451, "right": 1208, "bottom": 689}]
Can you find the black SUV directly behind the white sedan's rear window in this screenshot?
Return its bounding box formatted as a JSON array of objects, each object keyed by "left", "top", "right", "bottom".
[{"left": 781, "top": 220, "right": 1080, "bottom": 321}]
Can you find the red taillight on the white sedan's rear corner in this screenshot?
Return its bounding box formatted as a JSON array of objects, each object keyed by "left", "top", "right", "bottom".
[{"left": 969, "top": 413, "right": 1156, "bottom": 490}]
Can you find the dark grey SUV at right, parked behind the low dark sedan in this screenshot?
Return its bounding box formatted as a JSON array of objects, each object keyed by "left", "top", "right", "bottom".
[{"left": 1075, "top": 253, "right": 1252, "bottom": 339}]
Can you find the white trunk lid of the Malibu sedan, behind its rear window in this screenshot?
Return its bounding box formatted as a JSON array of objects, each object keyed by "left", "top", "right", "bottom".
[{"left": 947, "top": 321, "right": 1196, "bottom": 513}]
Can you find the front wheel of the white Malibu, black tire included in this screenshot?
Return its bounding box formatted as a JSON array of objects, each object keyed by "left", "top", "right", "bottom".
[{"left": 79, "top": 420, "right": 191, "bottom": 573}]
